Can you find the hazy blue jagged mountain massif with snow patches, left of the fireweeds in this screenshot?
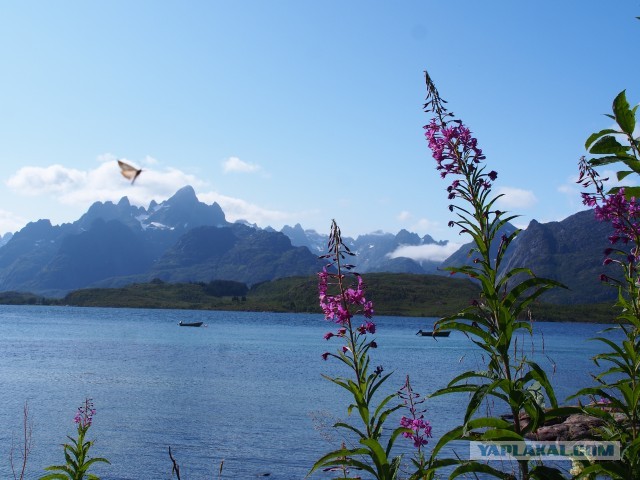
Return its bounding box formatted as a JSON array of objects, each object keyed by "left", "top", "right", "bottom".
[{"left": 0, "top": 186, "right": 320, "bottom": 296}]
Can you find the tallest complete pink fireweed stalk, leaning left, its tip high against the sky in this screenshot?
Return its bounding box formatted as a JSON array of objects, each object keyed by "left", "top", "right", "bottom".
[{"left": 424, "top": 73, "right": 560, "bottom": 480}]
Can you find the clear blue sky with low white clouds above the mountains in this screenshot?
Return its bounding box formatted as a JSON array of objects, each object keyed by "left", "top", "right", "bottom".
[{"left": 0, "top": 0, "right": 640, "bottom": 258}]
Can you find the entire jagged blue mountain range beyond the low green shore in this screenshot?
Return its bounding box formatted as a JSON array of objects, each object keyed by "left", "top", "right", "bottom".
[{"left": 0, "top": 186, "right": 616, "bottom": 303}]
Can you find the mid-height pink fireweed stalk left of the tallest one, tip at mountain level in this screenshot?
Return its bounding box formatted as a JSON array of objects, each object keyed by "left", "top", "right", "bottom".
[{"left": 309, "top": 220, "right": 430, "bottom": 480}]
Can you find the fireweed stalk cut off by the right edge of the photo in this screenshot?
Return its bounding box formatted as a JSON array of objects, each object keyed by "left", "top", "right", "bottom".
[{"left": 575, "top": 91, "right": 640, "bottom": 479}]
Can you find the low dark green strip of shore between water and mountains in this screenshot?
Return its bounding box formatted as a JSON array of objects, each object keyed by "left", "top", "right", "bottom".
[{"left": 0, "top": 273, "right": 615, "bottom": 323}]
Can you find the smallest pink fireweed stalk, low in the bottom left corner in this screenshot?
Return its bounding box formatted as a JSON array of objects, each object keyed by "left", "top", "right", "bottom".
[{"left": 40, "top": 398, "right": 109, "bottom": 480}]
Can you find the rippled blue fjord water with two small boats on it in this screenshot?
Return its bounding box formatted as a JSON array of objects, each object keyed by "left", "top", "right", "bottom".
[{"left": 0, "top": 306, "right": 620, "bottom": 480}]
